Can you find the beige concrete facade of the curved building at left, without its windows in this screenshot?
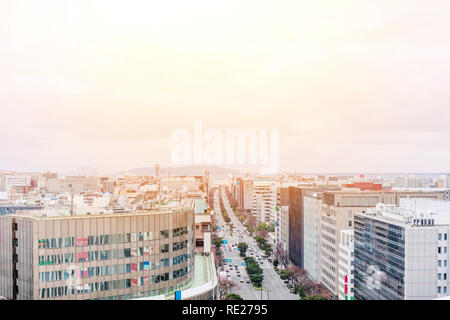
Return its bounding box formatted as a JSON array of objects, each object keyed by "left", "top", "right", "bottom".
[{"left": 0, "top": 210, "right": 194, "bottom": 300}]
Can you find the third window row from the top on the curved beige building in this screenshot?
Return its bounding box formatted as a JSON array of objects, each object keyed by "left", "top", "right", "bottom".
[{"left": 39, "top": 254, "right": 189, "bottom": 282}]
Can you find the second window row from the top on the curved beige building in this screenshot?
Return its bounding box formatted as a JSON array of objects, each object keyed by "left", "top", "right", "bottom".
[{"left": 39, "top": 244, "right": 192, "bottom": 265}]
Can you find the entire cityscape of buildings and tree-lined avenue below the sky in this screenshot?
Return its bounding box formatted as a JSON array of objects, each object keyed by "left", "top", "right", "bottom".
[{"left": 0, "top": 170, "right": 450, "bottom": 300}]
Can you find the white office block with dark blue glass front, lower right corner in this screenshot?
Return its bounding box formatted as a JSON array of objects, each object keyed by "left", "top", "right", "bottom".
[{"left": 354, "top": 198, "right": 450, "bottom": 300}]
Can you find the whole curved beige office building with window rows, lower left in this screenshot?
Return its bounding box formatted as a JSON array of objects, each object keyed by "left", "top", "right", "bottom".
[{"left": 0, "top": 206, "right": 194, "bottom": 300}]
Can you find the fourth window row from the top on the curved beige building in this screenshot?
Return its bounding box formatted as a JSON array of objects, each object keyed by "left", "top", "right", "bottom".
[{"left": 39, "top": 268, "right": 188, "bottom": 299}]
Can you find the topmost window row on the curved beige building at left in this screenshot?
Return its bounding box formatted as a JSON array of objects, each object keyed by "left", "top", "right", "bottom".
[{"left": 38, "top": 227, "right": 188, "bottom": 249}]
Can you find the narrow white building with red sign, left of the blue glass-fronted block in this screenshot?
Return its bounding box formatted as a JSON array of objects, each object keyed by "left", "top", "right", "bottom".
[{"left": 338, "top": 229, "right": 355, "bottom": 300}]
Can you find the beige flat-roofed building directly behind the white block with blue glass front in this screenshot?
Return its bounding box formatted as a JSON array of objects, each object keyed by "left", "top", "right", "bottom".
[{"left": 320, "top": 188, "right": 444, "bottom": 296}]
